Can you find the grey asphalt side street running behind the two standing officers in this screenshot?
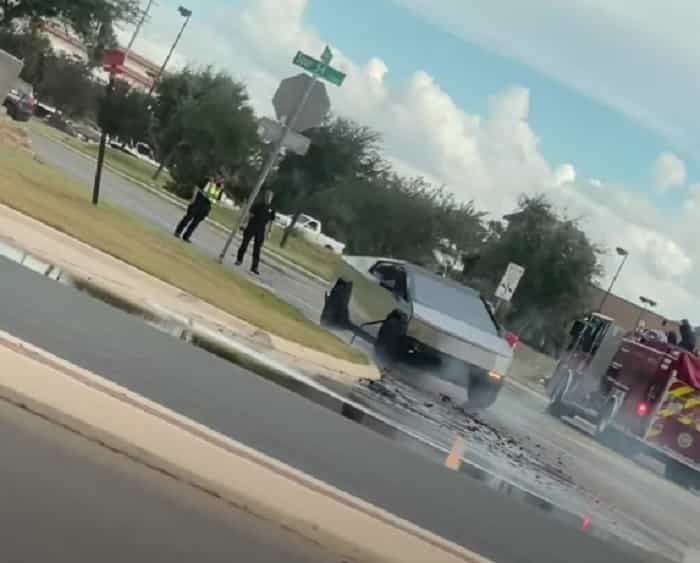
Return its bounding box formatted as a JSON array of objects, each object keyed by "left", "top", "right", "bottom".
[{"left": 30, "top": 131, "right": 323, "bottom": 319}]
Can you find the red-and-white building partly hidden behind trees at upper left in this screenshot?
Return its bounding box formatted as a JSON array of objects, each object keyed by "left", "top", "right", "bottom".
[{"left": 43, "top": 22, "right": 160, "bottom": 91}]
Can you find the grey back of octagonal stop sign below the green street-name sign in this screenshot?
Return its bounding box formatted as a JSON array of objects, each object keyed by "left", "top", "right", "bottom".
[{"left": 272, "top": 74, "right": 331, "bottom": 131}]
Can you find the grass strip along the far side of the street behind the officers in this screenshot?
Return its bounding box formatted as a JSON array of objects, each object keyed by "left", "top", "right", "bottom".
[{"left": 27, "top": 119, "right": 340, "bottom": 281}]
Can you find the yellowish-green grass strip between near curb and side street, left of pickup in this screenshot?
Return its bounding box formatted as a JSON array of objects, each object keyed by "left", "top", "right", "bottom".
[{"left": 0, "top": 142, "right": 367, "bottom": 363}]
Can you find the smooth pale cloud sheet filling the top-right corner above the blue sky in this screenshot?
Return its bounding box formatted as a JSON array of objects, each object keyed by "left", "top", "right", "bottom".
[{"left": 394, "top": 0, "right": 700, "bottom": 153}]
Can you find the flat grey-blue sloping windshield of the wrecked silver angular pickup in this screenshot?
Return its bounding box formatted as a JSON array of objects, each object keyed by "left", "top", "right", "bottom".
[{"left": 413, "top": 271, "right": 498, "bottom": 334}]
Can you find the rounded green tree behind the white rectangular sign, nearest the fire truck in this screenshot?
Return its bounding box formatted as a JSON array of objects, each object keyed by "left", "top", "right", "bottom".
[{"left": 466, "top": 195, "right": 602, "bottom": 353}]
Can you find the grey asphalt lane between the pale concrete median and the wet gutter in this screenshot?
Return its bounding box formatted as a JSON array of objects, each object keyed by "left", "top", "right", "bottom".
[{"left": 0, "top": 259, "right": 652, "bottom": 563}]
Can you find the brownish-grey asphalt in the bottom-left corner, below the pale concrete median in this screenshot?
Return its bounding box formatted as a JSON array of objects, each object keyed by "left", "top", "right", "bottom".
[{"left": 0, "top": 392, "right": 342, "bottom": 563}]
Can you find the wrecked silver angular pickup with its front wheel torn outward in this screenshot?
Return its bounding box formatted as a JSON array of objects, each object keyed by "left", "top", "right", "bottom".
[{"left": 321, "top": 256, "right": 513, "bottom": 410}]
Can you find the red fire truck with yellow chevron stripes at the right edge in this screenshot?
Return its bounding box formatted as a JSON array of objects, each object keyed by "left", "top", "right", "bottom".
[{"left": 547, "top": 314, "right": 700, "bottom": 489}]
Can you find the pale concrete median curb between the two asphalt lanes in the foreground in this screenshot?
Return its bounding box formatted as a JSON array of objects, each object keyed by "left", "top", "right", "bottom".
[{"left": 0, "top": 332, "right": 490, "bottom": 563}]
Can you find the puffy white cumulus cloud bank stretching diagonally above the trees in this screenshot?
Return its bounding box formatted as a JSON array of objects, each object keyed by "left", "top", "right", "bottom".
[{"left": 123, "top": 0, "right": 700, "bottom": 321}]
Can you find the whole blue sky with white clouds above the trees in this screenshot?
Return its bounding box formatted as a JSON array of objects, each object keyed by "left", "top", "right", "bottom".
[{"left": 121, "top": 0, "right": 700, "bottom": 324}]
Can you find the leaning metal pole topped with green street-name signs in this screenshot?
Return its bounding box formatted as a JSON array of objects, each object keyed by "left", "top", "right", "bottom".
[{"left": 219, "top": 47, "right": 345, "bottom": 264}]
